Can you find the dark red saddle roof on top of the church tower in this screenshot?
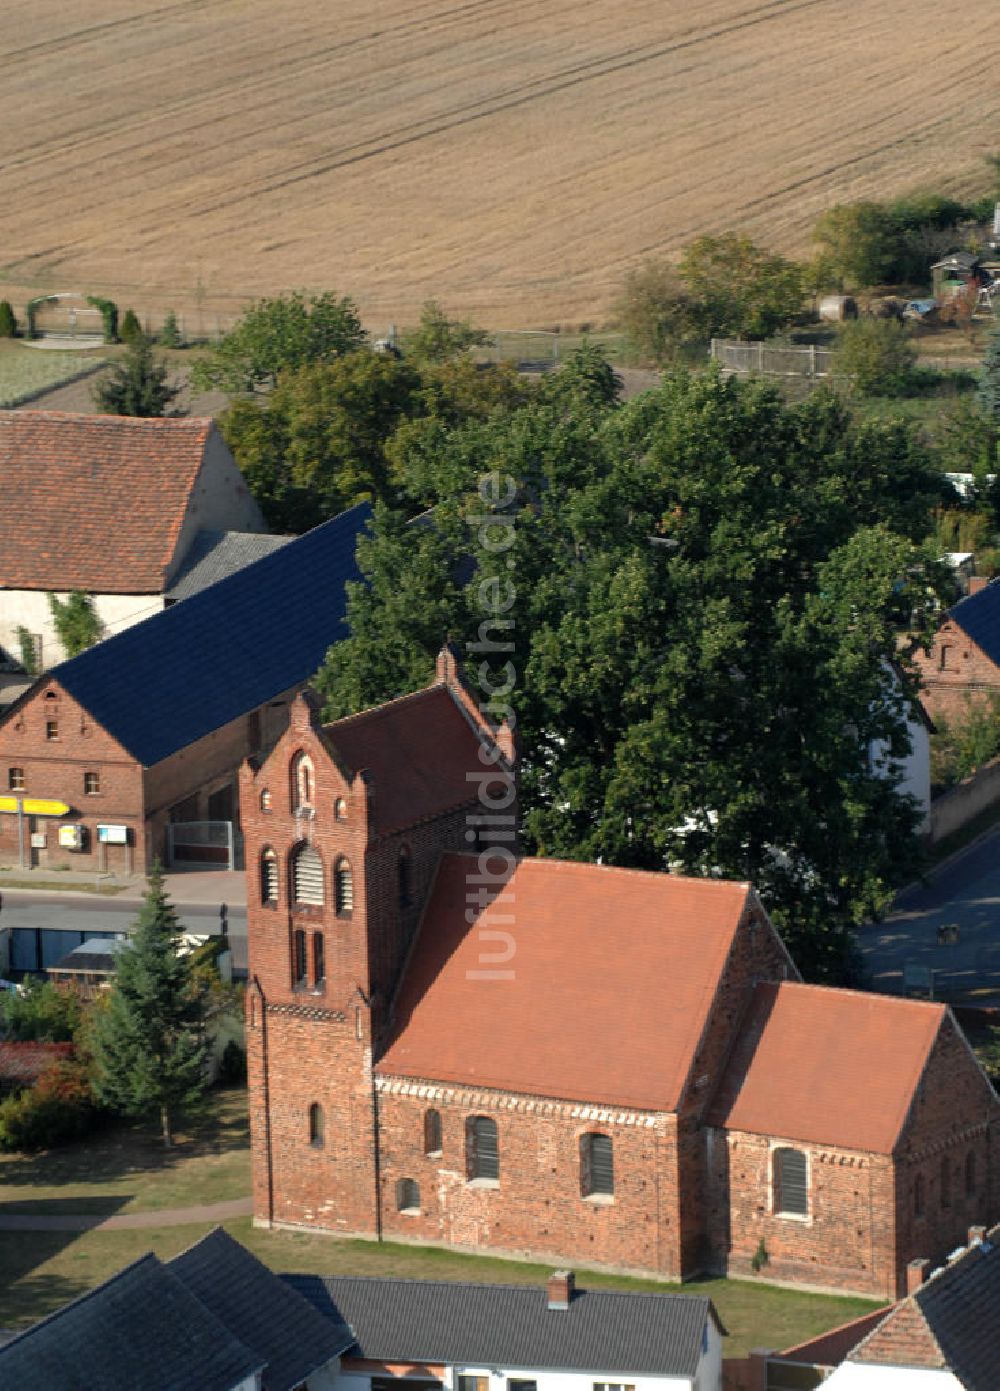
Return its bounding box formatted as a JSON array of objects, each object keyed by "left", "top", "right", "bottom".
[{"left": 323, "top": 684, "right": 488, "bottom": 833}]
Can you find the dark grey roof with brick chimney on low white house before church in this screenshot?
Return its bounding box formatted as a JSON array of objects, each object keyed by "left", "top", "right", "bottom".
[{"left": 281, "top": 1276, "right": 725, "bottom": 1378}]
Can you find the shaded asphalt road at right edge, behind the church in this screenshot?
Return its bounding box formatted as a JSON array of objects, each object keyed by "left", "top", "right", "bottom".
[{"left": 860, "top": 829, "right": 1000, "bottom": 1004}]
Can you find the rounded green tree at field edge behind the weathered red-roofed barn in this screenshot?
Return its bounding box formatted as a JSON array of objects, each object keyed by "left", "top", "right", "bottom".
[{"left": 191, "top": 291, "right": 364, "bottom": 394}]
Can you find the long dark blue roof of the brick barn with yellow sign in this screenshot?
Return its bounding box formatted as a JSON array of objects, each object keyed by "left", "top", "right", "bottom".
[{"left": 46, "top": 504, "right": 371, "bottom": 768}]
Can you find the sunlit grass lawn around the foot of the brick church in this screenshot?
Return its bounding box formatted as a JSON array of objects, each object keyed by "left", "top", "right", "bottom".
[{"left": 0, "top": 1089, "right": 873, "bottom": 1356}]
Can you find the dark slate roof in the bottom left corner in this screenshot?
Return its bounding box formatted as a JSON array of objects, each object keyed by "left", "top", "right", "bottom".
[{"left": 0, "top": 1255, "right": 261, "bottom": 1391}]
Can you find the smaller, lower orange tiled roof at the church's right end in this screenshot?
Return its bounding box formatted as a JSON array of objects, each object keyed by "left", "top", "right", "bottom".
[{"left": 708, "top": 981, "right": 946, "bottom": 1155}]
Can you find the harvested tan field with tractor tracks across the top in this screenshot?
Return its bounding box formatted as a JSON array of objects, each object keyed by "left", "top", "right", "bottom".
[{"left": 0, "top": 0, "right": 1000, "bottom": 331}]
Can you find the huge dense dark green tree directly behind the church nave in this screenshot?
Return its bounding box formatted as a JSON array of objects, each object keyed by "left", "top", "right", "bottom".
[{"left": 320, "top": 362, "right": 943, "bottom": 978}]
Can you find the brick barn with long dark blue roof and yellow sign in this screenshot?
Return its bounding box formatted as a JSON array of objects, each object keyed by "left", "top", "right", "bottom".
[{"left": 0, "top": 506, "right": 370, "bottom": 874}]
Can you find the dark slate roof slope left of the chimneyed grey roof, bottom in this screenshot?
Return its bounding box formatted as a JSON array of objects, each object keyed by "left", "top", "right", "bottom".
[{"left": 167, "top": 1227, "right": 353, "bottom": 1391}]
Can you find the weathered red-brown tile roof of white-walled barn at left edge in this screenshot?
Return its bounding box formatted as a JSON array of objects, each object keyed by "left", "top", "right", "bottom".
[{"left": 0, "top": 410, "right": 211, "bottom": 594}]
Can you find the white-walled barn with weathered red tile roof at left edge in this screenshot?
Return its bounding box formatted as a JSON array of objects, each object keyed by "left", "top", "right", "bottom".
[{"left": 0, "top": 410, "right": 269, "bottom": 669}]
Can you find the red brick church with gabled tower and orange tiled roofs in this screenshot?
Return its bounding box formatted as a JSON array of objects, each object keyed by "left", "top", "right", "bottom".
[{"left": 241, "top": 650, "right": 1000, "bottom": 1298}]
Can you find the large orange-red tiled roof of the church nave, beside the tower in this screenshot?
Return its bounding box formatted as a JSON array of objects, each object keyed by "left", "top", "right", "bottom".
[{"left": 378, "top": 854, "right": 750, "bottom": 1110}]
